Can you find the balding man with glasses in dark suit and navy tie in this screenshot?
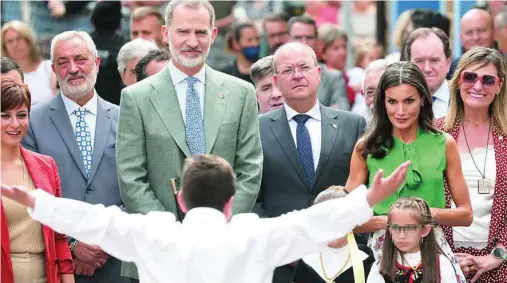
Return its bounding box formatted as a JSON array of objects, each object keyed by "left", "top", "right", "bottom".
[{"left": 258, "top": 43, "right": 366, "bottom": 283}]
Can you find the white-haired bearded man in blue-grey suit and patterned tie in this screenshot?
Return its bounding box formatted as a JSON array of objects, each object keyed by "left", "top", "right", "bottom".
[{"left": 23, "top": 31, "right": 128, "bottom": 283}]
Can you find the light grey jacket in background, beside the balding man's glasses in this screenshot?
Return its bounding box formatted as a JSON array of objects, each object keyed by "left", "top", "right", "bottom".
[{"left": 317, "top": 64, "right": 351, "bottom": 110}]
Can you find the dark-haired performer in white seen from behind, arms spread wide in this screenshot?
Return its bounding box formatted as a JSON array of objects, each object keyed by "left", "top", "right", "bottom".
[{"left": 1, "top": 155, "right": 409, "bottom": 283}]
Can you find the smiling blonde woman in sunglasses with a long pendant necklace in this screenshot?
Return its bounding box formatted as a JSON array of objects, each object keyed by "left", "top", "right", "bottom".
[{"left": 435, "top": 47, "right": 507, "bottom": 283}]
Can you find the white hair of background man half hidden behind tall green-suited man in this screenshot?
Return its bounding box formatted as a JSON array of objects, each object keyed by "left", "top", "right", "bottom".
[{"left": 116, "top": 38, "right": 158, "bottom": 74}]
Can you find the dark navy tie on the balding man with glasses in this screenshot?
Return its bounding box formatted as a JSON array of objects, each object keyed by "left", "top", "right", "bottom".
[{"left": 292, "top": 114, "right": 315, "bottom": 188}]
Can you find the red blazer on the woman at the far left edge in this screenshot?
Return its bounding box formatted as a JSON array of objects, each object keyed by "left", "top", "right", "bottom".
[{"left": 0, "top": 147, "right": 73, "bottom": 283}]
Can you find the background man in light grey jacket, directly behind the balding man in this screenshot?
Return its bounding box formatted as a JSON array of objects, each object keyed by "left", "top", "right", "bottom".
[{"left": 287, "top": 16, "right": 350, "bottom": 110}]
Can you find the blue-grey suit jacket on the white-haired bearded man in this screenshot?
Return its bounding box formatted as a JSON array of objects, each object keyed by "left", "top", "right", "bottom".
[{"left": 22, "top": 93, "right": 128, "bottom": 283}]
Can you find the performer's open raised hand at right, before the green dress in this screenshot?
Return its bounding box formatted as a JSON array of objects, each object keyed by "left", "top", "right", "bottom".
[{"left": 366, "top": 161, "right": 410, "bottom": 207}]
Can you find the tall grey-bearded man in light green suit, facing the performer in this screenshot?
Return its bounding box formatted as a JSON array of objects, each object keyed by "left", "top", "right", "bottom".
[{"left": 116, "top": 0, "right": 262, "bottom": 282}]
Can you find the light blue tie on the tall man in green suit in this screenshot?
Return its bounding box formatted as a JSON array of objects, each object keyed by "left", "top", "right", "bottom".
[{"left": 185, "top": 77, "right": 206, "bottom": 155}]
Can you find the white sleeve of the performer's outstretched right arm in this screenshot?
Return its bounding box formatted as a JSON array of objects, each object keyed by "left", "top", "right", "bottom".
[{"left": 257, "top": 185, "right": 373, "bottom": 266}]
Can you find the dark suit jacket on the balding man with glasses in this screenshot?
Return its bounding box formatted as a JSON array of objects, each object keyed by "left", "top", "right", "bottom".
[{"left": 258, "top": 105, "right": 366, "bottom": 217}]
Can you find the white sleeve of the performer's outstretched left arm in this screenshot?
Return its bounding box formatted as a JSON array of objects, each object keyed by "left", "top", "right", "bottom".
[{"left": 28, "top": 189, "right": 179, "bottom": 262}]
